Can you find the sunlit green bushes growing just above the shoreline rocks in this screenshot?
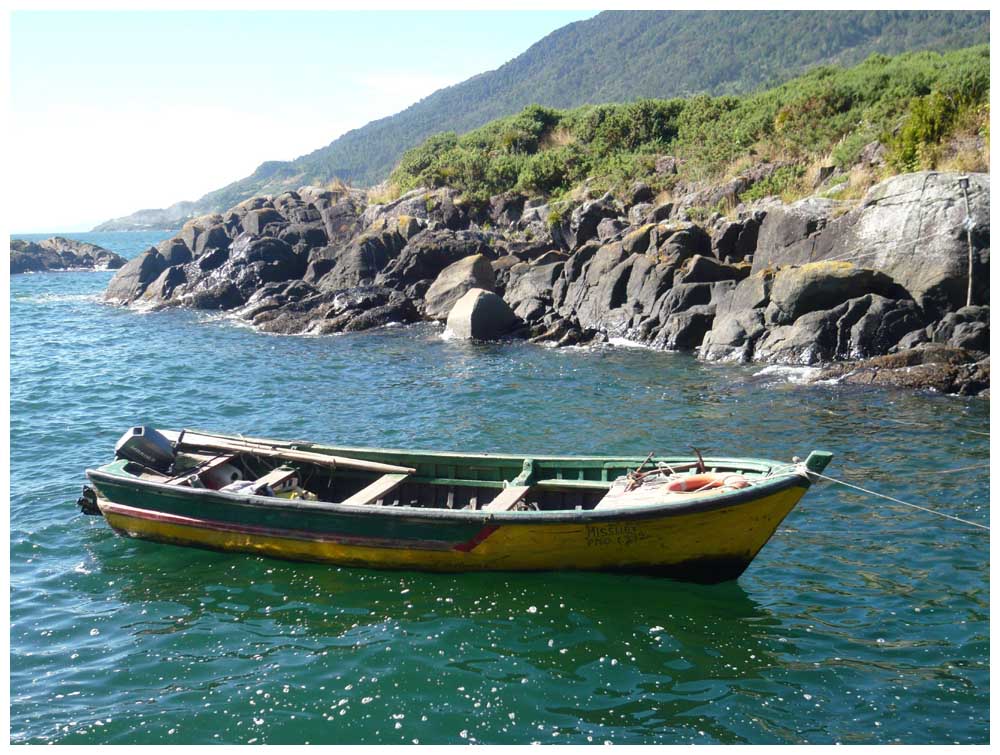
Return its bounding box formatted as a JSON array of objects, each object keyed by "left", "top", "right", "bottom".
[{"left": 390, "top": 45, "right": 990, "bottom": 210}]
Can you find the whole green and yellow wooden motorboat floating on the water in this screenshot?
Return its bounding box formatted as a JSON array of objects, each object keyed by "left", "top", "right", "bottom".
[{"left": 79, "top": 427, "right": 831, "bottom": 582}]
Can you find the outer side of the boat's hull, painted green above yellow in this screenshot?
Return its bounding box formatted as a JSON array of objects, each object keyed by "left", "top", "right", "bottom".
[{"left": 91, "top": 474, "right": 808, "bottom": 583}]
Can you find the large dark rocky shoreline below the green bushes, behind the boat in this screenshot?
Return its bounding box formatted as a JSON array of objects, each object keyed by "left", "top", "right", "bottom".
[{"left": 106, "top": 170, "right": 989, "bottom": 394}]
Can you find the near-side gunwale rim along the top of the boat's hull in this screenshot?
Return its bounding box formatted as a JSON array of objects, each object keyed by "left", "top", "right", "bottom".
[{"left": 86, "top": 457, "right": 810, "bottom": 524}]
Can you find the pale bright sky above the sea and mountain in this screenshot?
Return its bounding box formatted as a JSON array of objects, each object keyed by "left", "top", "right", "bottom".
[{"left": 7, "top": 10, "right": 596, "bottom": 233}]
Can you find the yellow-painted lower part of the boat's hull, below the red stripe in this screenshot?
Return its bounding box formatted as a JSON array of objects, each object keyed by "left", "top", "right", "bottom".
[{"left": 104, "top": 487, "right": 805, "bottom": 571}]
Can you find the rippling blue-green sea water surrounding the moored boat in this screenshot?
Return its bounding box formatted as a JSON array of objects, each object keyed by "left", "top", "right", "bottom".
[{"left": 10, "top": 233, "right": 989, "bottom": 744}]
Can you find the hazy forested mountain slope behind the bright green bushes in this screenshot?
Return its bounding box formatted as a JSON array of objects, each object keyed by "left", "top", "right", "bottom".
[{"left": 95, "top": 11, "right": 989, "bottom": 230}]
